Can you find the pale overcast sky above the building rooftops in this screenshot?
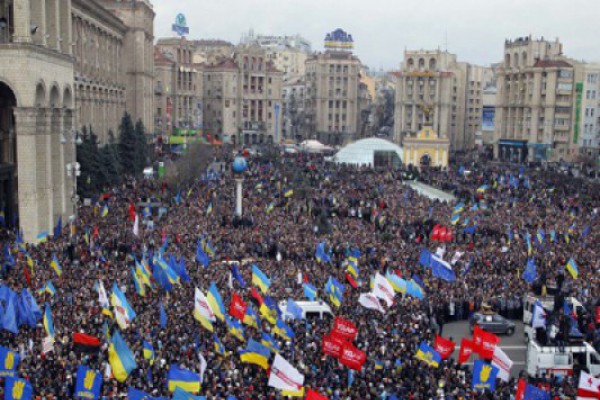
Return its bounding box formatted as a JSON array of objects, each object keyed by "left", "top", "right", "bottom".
[{"left": 152, "top": 0, "right": 600, "bottom": 70}]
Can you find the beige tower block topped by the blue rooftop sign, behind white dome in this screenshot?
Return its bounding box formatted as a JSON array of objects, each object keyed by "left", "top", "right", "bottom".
[{"left": 305, "top": 50, "right": 366, "bottom": 145}]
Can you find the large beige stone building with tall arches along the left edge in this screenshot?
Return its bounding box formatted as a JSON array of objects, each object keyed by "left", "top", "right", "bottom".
[{"left": 0, "top": 0, "right": 154, "bottom": 241}]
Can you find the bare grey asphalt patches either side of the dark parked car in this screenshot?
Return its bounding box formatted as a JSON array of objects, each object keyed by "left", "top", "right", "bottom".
[{"left": 443, "top": 321, "right": 527, "bottom": 377}]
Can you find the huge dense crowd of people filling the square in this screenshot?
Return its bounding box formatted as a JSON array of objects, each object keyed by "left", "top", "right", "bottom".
[{"left": 0, "top": 149, "right": 600, "bottom": 399}]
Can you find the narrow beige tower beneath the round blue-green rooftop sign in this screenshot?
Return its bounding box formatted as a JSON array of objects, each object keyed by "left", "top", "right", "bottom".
[{"left": 154, "top": 37, "right": 202, "bottom": 134}]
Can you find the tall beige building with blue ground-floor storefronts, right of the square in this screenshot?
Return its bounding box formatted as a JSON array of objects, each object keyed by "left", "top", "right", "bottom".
[{"left": 494, "top": 36, "right": 580, "bottom": 162}]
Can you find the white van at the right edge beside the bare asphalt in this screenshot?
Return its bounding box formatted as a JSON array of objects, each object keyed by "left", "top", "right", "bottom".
[{"left": 527, "top": 340, "right": 600, "bottom": 377}]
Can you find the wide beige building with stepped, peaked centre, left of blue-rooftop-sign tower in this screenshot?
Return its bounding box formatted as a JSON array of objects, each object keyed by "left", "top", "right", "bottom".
[{"left": 203, "top": 45, "right": 283, "bottom": 144}]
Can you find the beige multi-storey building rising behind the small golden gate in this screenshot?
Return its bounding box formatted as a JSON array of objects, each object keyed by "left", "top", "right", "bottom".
[{"left": 394, "top": 50, "right": 491, "bottom": 151}]
